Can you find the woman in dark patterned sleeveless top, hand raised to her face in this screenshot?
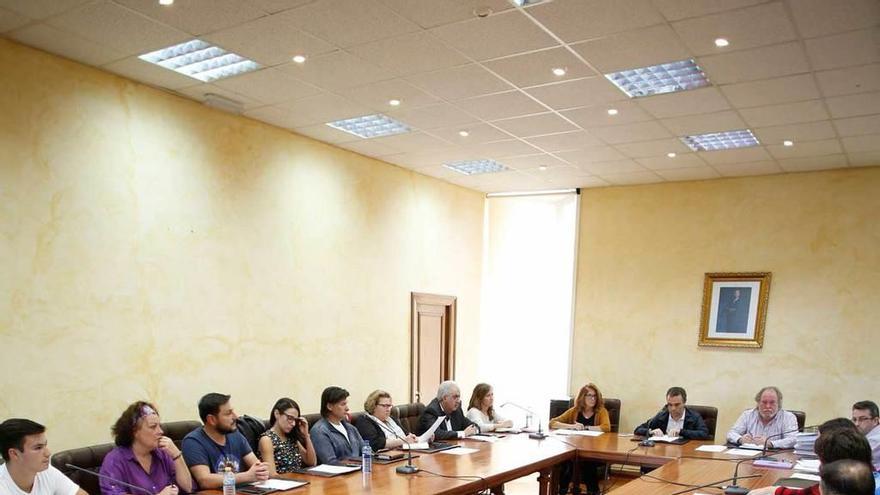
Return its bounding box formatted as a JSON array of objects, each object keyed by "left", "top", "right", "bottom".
[{"left": 257, "top": 397, "right": 318, "bottom": 476}]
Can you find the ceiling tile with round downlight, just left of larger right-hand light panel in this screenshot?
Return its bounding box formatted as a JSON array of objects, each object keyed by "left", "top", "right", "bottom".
[{"left": 486, "top": 47, "right": 596, "bottom": 88}]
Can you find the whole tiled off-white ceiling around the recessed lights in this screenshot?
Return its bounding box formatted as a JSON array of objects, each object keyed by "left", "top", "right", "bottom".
[{"left": 0, "top": 0, "right": 880, "bottom": 192}]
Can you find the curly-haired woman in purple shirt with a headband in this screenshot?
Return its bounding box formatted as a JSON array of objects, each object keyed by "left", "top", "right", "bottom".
[{"left": 100, "top": 401, "right": 193, "bottom": 495}]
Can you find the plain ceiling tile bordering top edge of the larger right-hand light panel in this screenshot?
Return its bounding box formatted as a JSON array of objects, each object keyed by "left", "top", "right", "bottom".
[{"left": 571, "top": 24, "right": 691, "bottom": 74}]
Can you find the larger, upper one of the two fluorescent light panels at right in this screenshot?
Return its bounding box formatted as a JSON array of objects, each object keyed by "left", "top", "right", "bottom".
[{"left": 605, "top": 59, "right": 709, "bottom": 98}]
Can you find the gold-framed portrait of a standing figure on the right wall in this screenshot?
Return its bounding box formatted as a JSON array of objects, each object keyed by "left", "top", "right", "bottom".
[{"left": 699, "top": 272, "right": 770, "bottom": 348}]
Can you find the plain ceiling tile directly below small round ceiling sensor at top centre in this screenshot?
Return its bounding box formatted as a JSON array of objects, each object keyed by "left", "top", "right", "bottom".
[{"left": 431, "top": 10, "right": 558, "bottom": 60}]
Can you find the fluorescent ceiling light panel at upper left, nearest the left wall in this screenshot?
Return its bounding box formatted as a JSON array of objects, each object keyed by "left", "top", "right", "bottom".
[{"left": 138, "top": 40, "right": 260, "bottom": 82}]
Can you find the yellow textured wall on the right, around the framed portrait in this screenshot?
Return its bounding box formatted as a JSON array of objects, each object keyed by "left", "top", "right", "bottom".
[{"left": 571, "top": 167, "right": 880, "bottom": 438}]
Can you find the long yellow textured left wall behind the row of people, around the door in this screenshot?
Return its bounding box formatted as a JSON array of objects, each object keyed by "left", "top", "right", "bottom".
[{"left": 0, "top": 40, "right": 483, "bottom": 450}]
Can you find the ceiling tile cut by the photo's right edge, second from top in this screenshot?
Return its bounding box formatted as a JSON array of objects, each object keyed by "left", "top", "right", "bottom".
[{"left": 806, "top": 28, "right": 880, "bottom": 70}]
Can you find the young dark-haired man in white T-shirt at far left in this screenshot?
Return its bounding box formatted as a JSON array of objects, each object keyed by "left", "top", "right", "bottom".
[{"left": 0, "top": 419, "right": 88, "bottom": 495}]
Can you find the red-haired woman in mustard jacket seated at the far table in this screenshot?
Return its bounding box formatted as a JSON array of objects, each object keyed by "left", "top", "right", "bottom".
[{"left": 550, "top": 383, "right": 611, "bottom": 494}]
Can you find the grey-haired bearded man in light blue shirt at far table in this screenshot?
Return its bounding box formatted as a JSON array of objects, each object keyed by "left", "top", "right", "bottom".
[{"left": 727, "top": 387, "right": 798, "bottom": 449}]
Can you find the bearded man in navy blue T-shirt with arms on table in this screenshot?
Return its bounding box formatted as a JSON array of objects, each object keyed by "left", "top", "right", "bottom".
[{"left": 182, "top": 393, "right": 269, "bottom": 490}]
